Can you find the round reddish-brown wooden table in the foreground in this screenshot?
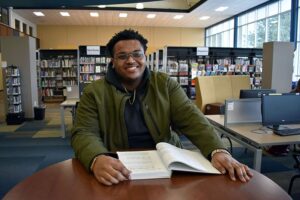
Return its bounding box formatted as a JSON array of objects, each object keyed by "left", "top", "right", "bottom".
[{"left": 4, "top": 159, "right": 291, "bottom": 200}]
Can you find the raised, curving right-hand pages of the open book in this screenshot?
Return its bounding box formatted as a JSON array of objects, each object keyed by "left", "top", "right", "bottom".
[{"left": 156, "top": 142, "right": 220, "bottom": 174}]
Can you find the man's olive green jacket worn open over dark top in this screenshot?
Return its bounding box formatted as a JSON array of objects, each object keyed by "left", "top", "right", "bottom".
[{"left": 71, "top": 72, "right": 224, "bottom": 170}]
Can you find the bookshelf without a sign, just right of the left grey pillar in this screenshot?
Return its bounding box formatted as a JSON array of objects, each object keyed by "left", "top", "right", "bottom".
[{"left": 38, "top": 49, "right": 78, "bottom": 102}]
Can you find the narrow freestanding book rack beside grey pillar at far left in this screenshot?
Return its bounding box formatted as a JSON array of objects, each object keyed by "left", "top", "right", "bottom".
[{"left": 5, "top": 65, "right": 25, "bottom": 125}]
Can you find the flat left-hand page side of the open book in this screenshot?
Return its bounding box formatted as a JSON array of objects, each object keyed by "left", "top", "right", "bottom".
[{"left": 117, "top": 150, "right": 171, "bottom": 180}]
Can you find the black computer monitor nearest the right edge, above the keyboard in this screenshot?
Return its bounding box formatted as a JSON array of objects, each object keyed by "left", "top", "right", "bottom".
[{"left": 261, "top": 93, "right": 300, "bottom": 130}]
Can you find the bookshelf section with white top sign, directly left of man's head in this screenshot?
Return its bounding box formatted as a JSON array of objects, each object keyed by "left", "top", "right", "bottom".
[{"left": 78, "top": 46, "right": 110, "bottom": 95}]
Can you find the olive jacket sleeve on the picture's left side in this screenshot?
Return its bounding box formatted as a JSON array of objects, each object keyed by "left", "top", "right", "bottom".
[{"left": 71, "top": 84, "right": 108, "bottom": 171}]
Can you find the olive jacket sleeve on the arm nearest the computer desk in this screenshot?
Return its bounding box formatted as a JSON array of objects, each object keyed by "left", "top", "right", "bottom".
[{"left": 168, "top": 79, "right": 225, "bottom": 158}]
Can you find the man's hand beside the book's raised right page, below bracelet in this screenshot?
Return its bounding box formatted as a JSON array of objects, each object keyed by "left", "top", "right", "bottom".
[{"left": 211, "top": 152, "right": 253, "bottom": 182}]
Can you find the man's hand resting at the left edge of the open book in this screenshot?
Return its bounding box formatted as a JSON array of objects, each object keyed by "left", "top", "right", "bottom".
[{"left": 92, "top": 155, "right": 130, "bottom": 185}]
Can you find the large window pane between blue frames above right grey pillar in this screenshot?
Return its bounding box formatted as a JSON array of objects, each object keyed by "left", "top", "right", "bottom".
[{"left": 237, "top": 0, "right": 291, "bottom": 48}]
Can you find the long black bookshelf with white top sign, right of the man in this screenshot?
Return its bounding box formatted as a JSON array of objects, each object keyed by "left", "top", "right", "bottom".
[{"left": 161, "top": 46, "right": 263, "bottom": 99}]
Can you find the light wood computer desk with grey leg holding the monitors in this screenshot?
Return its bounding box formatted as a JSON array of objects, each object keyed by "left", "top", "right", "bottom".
[{"left": 206, "top": 115, "right": 300, "bottom": 172}]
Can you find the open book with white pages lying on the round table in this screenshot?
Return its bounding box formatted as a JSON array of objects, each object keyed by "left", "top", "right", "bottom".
[{"left": 117, "top": 142, "right": 221, "bottom": 180}]
